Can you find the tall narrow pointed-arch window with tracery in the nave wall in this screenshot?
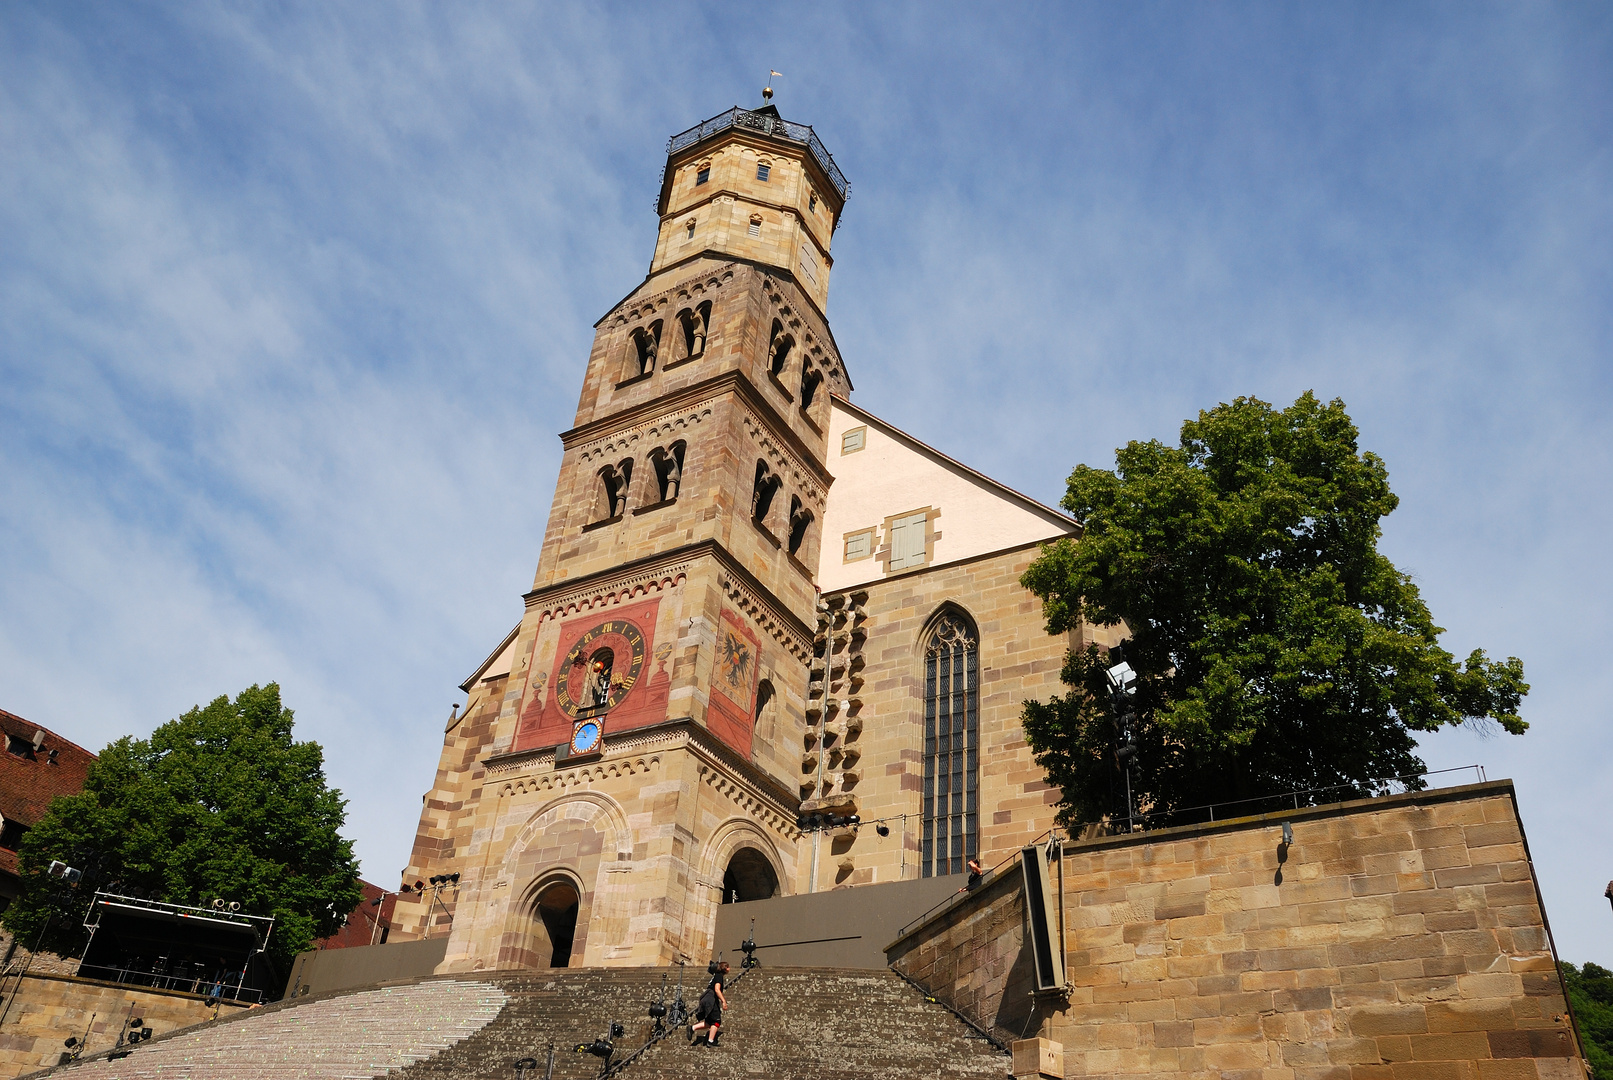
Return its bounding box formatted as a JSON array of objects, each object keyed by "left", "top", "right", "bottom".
[{"left": 921, "top": 611, "right": 981, "bottom": 877}]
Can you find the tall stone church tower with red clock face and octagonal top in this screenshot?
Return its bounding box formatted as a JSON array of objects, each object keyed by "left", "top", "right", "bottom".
[{"left": 395, "top": 106, "right": 850, "bottom": 970}]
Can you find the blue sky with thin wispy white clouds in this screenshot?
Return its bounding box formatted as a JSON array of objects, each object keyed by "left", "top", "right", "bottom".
[{"left": 0, "top": 0, "right": 1613, "bottom": 964}]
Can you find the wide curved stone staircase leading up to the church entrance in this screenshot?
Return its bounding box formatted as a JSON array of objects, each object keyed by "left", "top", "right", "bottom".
[{"left": 25, "top": 967, "right": 1010, "bottom": 1080}]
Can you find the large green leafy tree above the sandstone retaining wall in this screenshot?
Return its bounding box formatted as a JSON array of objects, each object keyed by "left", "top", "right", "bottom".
[{"left": 1021, "top": 393, "right": 1529, "bottom": 825}]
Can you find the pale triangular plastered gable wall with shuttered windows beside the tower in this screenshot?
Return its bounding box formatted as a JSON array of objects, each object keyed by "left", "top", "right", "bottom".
[{"left": 818, "top": 398, "right": 1077, "bottom": 593}]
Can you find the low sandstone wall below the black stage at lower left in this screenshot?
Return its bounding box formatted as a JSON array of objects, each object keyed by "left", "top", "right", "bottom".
[{"left": 0, "top": 970, "right": 245, "bottom": 1078}]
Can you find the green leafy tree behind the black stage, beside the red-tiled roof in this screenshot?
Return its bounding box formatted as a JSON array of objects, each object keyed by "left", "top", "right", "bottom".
[{"left": 0, "top": 683, "right": 361, "bottom": 972}]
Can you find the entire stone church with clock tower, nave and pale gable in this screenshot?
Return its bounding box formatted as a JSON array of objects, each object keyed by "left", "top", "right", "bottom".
[{"left": 395, "top": 106, "right": 1109, "bottom": 970}]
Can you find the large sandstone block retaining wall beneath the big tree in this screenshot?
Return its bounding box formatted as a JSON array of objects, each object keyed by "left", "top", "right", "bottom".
[{"left": 890, "top": 782, "right": 1586, "bottom": 1080}]
